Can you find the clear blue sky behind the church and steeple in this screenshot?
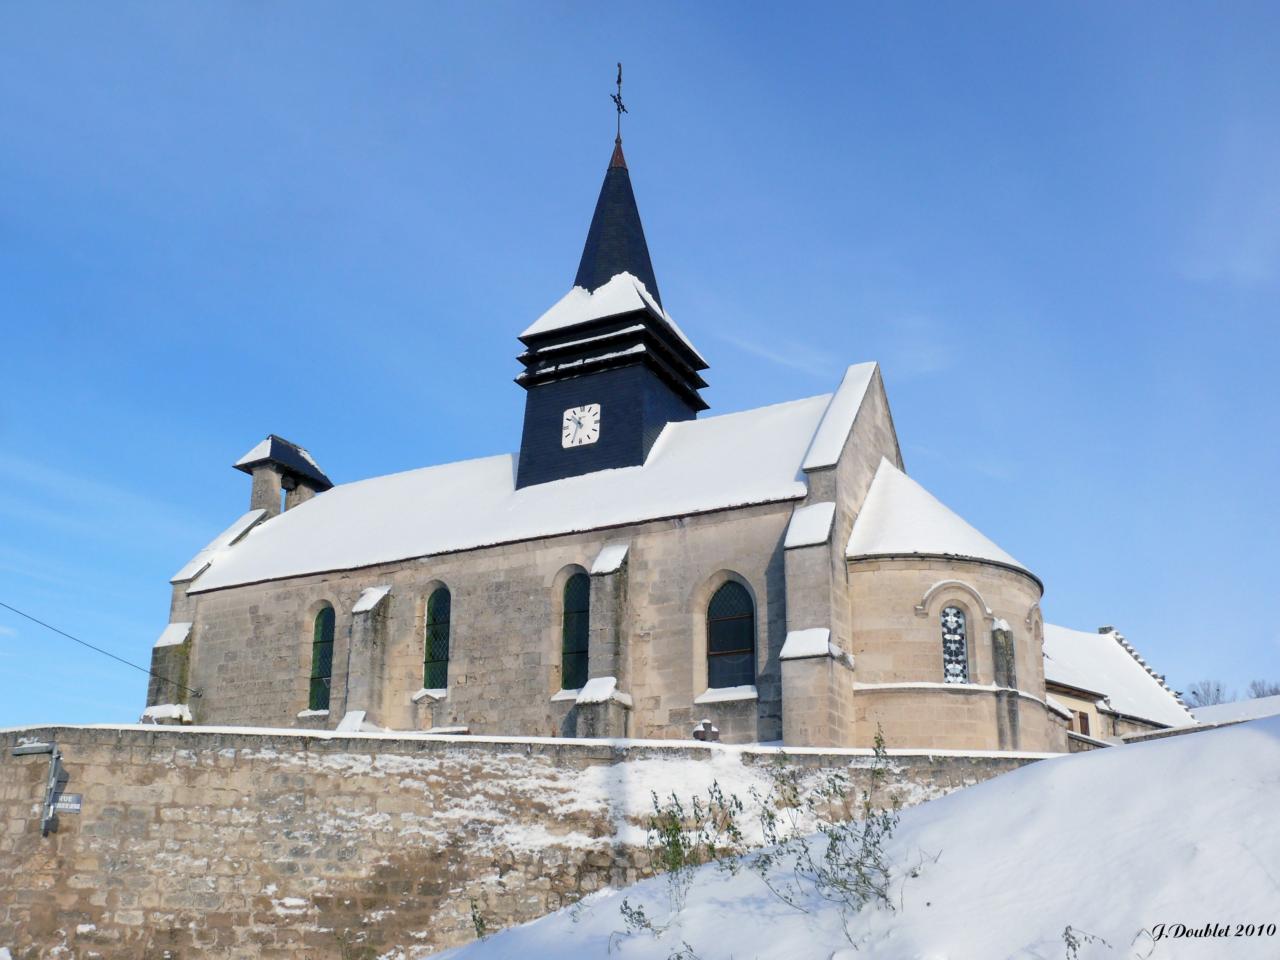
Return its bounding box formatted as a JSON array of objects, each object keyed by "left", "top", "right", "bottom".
[{"left": 0, "top": 3, "right": 1280, "bottom": 724}]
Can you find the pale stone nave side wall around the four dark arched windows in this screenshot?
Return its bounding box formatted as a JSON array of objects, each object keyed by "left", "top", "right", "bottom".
[{"left": 166, "top": 502, "right": 792, "bottom": 740}]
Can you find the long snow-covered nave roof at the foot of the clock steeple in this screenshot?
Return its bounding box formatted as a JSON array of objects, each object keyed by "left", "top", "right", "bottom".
[{"left": 191, "top": 396, "right": 831, "bottom": 593}]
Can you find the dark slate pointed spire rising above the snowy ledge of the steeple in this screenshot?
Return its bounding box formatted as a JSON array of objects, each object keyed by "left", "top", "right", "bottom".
[{"left": 573, "top": 137, "right": 662, "bottom": 305}]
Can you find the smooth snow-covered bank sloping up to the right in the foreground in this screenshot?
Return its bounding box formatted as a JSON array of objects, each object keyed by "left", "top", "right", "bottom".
[{"left": 443, "top": 717, "right": 1280, "bottom": 960}]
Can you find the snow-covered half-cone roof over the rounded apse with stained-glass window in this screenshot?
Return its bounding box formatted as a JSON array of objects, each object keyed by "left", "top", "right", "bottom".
[{"left": 846, "top": 460, "right": 1030, "bottom": 572}]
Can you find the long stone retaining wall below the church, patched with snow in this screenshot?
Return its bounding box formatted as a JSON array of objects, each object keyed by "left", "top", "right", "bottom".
[{"left": 0, "top": 727, "right": 1037, "bottom": 960}]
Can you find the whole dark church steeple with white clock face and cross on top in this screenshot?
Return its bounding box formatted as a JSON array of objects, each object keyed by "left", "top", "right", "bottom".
[{"left": 516, "top": 75, "right": 707, "bottom": 486}]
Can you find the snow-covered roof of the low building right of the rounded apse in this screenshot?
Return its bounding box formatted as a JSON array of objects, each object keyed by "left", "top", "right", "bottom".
[{"left": 1044, "top": 623, "right": 1192, "bottom": 727}]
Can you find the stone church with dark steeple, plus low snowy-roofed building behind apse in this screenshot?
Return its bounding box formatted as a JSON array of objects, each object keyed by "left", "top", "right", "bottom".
[{"left": 143, "top": 128, "right": 1192, "bottom": 753}]
